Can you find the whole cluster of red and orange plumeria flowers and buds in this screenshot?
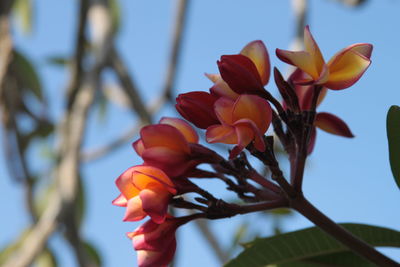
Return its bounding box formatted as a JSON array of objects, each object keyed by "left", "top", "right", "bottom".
[{"left": 113, "top": 27, "right": 372, "bottom": 267}]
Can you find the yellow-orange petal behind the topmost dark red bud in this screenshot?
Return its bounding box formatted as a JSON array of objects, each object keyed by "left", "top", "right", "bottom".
[{"left": 240, "top": 40, "right": 271, "bottom": 85}]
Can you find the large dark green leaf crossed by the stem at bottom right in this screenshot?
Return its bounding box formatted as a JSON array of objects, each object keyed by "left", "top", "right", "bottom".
[{"left": 225, "top": 224, "right": 400, "bottom": 267}]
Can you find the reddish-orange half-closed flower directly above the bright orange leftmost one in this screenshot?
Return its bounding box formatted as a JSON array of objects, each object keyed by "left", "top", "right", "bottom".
[{"left": 133, "top": 117, "right": 220, "bottom": 178}]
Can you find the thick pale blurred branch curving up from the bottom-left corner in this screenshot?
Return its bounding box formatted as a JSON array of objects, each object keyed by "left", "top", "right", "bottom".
[{"left": 3, "top": 3, "right": 112, "bottom": 267}]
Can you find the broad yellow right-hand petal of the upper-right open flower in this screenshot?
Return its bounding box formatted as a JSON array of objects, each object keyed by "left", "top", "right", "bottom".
[{"left": 325, "top": 48, "right": 371, "bottom": 90}]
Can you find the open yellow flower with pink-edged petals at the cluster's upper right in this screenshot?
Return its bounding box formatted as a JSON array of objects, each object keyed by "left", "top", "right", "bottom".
[{"left": 276, "top": 26, "right": 372, "bottom": 90}]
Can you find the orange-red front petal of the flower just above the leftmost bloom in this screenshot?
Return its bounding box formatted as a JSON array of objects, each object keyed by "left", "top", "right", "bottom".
[{"left": 140, "top": 124, "right": 190, "bottom": 153}]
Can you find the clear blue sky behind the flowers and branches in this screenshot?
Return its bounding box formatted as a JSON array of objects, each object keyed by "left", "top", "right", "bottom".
[{"left": 0, "top": 0, "right": 400, "bottom": 267}]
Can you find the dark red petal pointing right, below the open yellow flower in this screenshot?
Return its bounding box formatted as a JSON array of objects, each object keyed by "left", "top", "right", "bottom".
[{"left": 314, "top": 112, "right": 354, "bottom": 137}]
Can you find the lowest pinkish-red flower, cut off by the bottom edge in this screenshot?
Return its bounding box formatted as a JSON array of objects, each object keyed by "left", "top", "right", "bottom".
[{"left": 127, "top": 216, "right": 187, "bottom": 267}]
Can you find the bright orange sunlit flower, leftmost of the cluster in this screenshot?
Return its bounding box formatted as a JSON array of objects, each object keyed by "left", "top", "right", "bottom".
[{"left": 113, "top": 165, "right": 177, "bottom": 224}]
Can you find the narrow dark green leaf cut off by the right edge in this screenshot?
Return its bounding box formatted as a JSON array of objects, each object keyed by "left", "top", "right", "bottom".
[{"left": 386, "top": 106, "right": 400, "bottom": 191}]
